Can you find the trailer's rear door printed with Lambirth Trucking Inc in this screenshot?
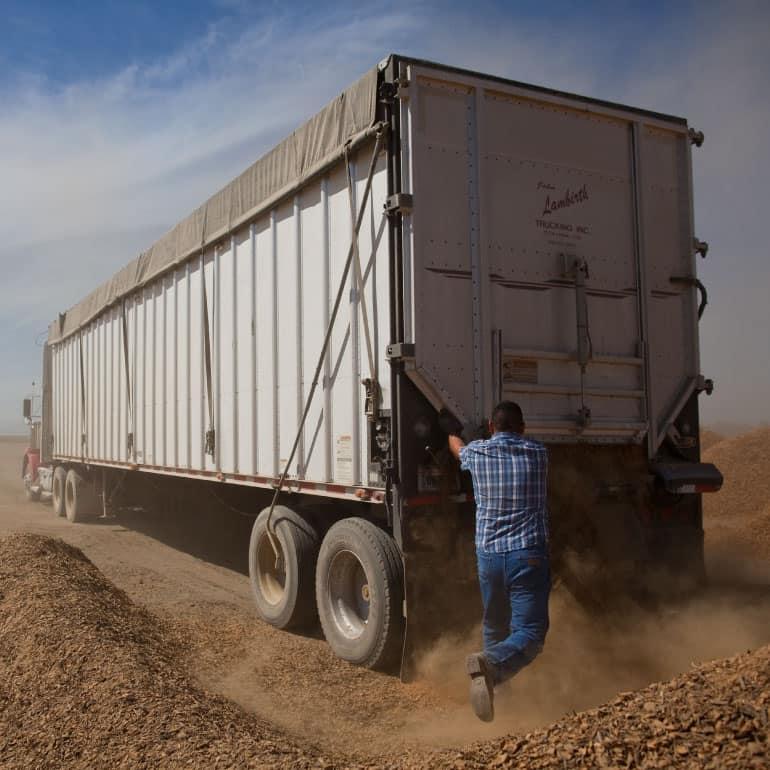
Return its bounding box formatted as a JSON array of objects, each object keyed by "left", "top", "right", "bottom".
[{"left": 402, "top": 64, "right": 698, "bottom": 453}]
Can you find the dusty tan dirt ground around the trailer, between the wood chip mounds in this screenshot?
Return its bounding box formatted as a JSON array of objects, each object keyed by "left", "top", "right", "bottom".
[{"left": 0, "top": 432, "right": 770, "bottom": 765}]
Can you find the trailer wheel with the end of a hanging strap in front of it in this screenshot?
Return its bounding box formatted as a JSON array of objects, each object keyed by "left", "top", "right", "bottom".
[{"left": 249, "top": 505, "right": 319, "bottom": 629}]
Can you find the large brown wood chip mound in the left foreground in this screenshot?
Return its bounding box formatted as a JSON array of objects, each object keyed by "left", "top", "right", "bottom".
[{"left": 0, "top": 535, "right": 319, "bottom": 768}]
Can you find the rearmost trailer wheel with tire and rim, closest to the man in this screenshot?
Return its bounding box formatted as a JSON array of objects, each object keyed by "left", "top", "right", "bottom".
[{"left": 316, "top": 518, "right": 404, "bottom": 669}]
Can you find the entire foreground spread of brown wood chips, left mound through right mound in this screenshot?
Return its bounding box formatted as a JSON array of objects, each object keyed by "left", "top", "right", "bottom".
[{"left": 0, "top": 535, "right": 770, "bottom": 770}]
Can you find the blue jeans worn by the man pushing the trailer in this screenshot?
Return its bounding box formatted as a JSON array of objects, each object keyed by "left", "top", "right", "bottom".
[{"left": 476, "top": 548, "right": 551, "bottom": 684}]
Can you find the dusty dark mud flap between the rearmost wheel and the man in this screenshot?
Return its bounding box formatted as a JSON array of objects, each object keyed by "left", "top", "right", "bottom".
[{"left": 401, "top": 498, "right": 481, "bottom": 681}]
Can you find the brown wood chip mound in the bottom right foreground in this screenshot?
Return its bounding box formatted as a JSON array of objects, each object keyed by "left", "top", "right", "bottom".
[{"left": 420, "top": 646, "right": 770, "bottom": 770}]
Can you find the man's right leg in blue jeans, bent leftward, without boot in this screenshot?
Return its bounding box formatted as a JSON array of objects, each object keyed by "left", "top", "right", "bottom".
[{"left": 484, "top": 551, "right": 551, "bottom": 684}]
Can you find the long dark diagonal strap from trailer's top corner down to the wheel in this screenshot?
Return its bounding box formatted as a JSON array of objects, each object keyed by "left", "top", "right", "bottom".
[{"left": 265, "top": 128, "right": 384, "bottom": 566}]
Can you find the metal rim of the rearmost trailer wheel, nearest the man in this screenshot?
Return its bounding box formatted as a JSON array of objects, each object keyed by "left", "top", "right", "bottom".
[{"left": 328, "top": 551, "right": 371, "bottom": 640}]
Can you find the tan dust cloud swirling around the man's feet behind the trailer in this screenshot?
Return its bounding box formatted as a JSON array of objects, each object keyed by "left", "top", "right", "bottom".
[{"left": 407, "top": 554, "right": 770, "bottom": 746}]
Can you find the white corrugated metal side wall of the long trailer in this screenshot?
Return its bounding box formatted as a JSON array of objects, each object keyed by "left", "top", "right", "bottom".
[{"left": 52, "top": 140, "right": 390, "bottom": 487}]
